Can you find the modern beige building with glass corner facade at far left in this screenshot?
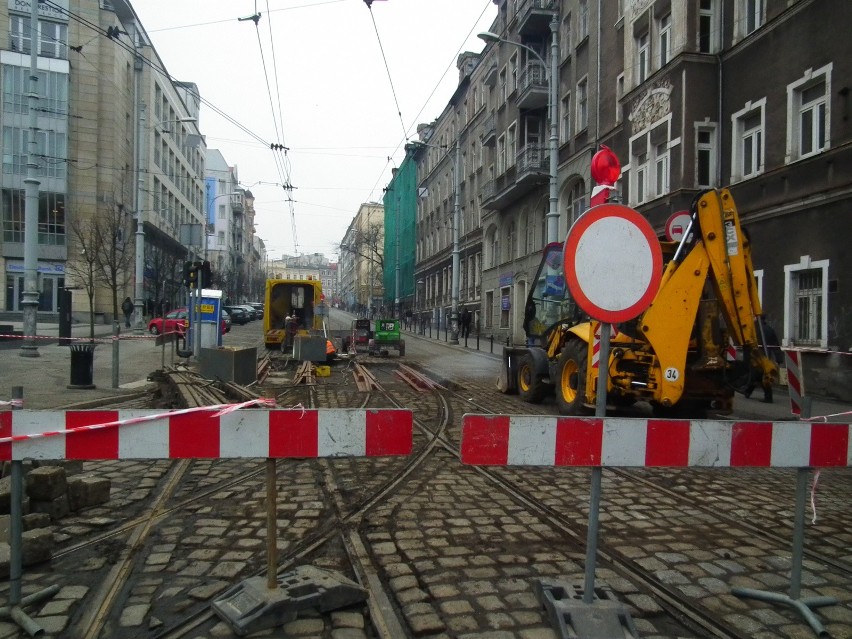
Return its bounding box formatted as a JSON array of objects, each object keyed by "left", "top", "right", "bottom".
[{"left": 0, "top": 0, "right": 204, "bottom": 321}]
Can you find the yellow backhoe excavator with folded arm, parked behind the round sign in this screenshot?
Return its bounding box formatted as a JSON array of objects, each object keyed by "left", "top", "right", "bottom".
[{"left": 498, "top": 189, "right": 778, "bottom": 418}]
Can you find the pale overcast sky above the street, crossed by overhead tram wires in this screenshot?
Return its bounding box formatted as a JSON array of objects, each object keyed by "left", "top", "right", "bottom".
[{"left": 134, "top": 0, "right": 497, "bottom": 257}]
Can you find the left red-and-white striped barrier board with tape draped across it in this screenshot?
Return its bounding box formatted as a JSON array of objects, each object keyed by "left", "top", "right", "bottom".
[{"left": 0, "top": 407, "right": 413, "bottom": 460}]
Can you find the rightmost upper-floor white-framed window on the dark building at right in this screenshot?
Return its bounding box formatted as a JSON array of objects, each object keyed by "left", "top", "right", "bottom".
[{"left": 787, "top": 64, "right": 832, "bottom": 162}]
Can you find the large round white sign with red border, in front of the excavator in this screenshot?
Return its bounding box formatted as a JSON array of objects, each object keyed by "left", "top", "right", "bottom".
[{"left": 564, "top": 204, "right": 663, "bottom": 324}]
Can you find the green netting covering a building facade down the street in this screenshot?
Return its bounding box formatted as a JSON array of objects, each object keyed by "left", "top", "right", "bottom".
[{"left": 382, "top": 143, "right": 418, "bottom": 317}]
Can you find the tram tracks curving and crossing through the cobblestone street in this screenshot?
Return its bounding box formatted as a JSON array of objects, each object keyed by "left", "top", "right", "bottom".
[{"left": 28, "top": 336, "right": 849, "bottom": 639}]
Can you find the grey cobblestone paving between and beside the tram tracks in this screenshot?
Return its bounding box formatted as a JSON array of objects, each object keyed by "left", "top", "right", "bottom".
[{"left": 0, "top": 316, "right": 852, "bottom": 639}]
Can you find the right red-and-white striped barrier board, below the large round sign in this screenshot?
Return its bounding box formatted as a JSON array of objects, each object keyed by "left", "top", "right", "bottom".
[{"left": 461, "top": 415, "right": 852, "bottom": 468}]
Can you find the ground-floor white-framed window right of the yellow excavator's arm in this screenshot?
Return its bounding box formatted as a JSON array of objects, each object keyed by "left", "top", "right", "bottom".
[{"left": 784, "top": 255, "right": 829, "bottom": 348}]
